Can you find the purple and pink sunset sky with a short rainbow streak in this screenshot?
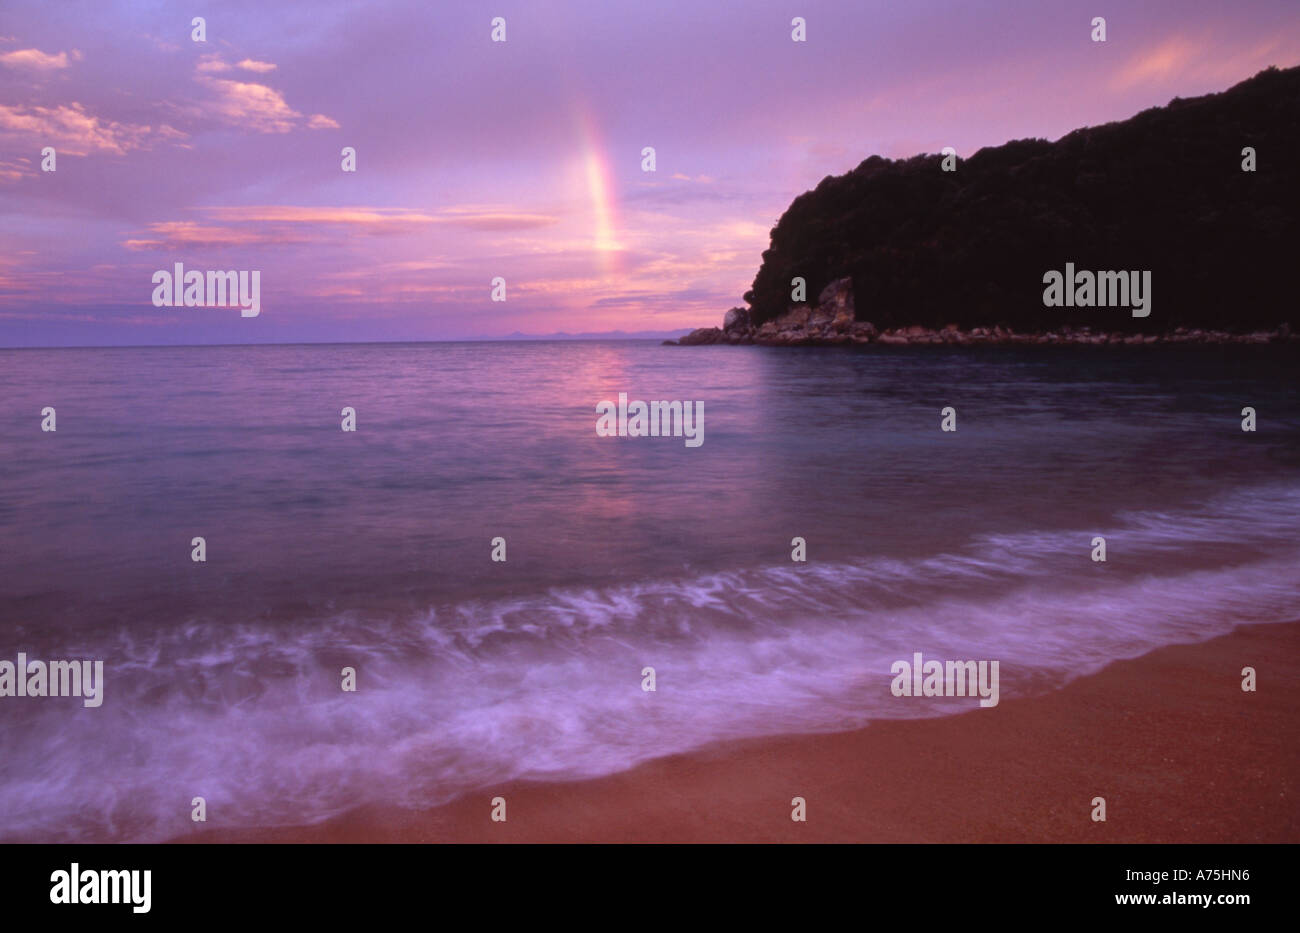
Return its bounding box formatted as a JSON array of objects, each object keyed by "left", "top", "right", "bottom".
[{"left": 0, "top": 0, "right": 1300, "bottom": 347}]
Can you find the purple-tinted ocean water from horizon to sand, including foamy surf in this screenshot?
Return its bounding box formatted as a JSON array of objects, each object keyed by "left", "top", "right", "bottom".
[{"left": 0, "top": 340, "right": 1300, "bottom": 841}]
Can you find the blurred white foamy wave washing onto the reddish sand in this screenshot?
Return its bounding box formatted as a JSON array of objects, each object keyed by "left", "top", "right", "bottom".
[{"left": 0, "top": 486, "right": 1300, "bottom": 841}]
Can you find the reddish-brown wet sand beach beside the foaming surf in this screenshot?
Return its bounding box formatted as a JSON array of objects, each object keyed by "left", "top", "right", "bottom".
[{"left": 173, "top": 621, "right": 1300, "bottom": 843}]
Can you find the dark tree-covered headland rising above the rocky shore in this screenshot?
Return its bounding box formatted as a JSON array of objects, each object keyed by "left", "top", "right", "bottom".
[{"left": 729, "top": 68, "right": 1300, "bottom": 333}]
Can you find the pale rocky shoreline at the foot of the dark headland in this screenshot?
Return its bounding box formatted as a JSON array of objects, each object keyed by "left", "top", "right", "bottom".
[{"left": 664, "top": 278, "right": 1300, "bottom": 347}]
